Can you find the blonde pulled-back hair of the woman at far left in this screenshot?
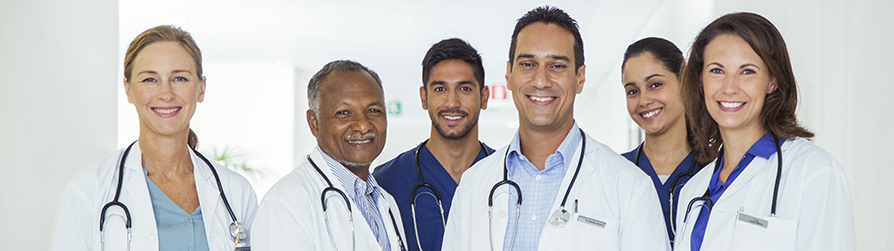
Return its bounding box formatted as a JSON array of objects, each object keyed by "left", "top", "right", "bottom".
[{"left": 124, "top": 25, "right": 202, "bottom": 149}]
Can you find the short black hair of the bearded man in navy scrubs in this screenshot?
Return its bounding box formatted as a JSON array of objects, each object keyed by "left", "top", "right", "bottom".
[{"left": 422, "top": 38, "right": 484, "bottom": 89}]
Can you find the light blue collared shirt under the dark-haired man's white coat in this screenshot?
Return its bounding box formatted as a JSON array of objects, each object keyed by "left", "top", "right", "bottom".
[{"left": 503, "top": 122, "right": 583, "bottom": 250}]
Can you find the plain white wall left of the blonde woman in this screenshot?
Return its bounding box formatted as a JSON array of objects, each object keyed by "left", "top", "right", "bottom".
[{"left": 0, "top": 0, "right": 119, "bottom": 250}]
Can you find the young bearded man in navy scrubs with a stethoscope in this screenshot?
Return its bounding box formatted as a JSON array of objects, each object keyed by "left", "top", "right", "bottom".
[{"left": 373, "top": 38, "right": 494, "bottom": 251}]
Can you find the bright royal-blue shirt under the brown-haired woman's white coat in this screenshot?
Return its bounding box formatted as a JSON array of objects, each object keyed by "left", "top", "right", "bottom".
[{"left": 691, "top": 132, "right": 784, "bottom": 251}]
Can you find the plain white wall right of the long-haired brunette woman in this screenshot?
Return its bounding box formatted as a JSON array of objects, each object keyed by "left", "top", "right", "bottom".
[{"left": 714, "top": 0, "right": 894, "bottom": 250}]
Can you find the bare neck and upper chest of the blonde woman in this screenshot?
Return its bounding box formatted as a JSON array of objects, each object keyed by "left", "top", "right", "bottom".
[{"left": 138, "top": 131, "right": 193, "bottom": 177}]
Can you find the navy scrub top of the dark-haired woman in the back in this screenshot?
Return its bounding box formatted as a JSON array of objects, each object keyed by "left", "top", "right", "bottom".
[{"left": 621, "top": 145, "right": 702, "bottom": 244}]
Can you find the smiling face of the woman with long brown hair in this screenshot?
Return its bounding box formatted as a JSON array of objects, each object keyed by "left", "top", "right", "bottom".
[{"left": 701, "top": 34, "right": 776, "bottom": 133}]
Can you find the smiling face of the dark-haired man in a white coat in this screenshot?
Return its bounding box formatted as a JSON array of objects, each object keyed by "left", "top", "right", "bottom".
[{"left": 506, "top": 22, "right": 586, "bottom": 131}]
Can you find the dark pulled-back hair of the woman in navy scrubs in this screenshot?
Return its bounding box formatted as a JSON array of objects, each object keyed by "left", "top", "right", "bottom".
[{"left": 621, "top": 37, "right": 686, "bottom": 79}]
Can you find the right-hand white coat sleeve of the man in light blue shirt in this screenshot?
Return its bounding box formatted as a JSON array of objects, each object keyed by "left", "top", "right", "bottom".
[{"left": 619, "top": 176, "right": 671, "bottom": 251}]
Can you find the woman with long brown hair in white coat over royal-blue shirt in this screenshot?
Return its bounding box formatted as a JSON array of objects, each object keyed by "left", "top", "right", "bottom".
[{"left": 674, "top": 13, "right": 856, "bottom": 251}]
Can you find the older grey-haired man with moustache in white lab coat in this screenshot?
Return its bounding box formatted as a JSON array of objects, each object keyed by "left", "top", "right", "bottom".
[{"left": 252, "top": 60, "right": 406, "bottom": 251}]
